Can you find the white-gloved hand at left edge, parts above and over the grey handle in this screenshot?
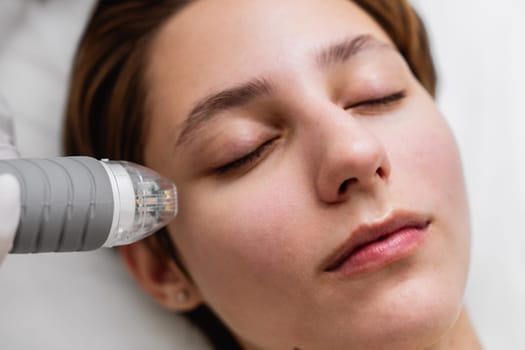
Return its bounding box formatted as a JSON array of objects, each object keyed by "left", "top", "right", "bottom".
[{"left": 0, "top": 96, "right": 20, "bottom": 263}]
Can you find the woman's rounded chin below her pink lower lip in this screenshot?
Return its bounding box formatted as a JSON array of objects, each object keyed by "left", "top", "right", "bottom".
[{"left": 312, "top": 263, "right": 466, "bottom": 350}]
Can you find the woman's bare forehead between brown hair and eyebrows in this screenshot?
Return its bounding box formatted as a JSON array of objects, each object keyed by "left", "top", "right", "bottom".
[{"left": 148, "top": 0, "right": 390, "bottom": 118}]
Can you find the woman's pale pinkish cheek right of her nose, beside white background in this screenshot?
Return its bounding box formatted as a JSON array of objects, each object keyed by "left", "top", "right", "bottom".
[{"left": 385, "top": 96, "right": 468, "bottom": 221}]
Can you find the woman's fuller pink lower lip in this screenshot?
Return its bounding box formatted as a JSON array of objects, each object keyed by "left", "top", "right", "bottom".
[{"left": 330, "top": 226, "right": 428, "bottom": 278}]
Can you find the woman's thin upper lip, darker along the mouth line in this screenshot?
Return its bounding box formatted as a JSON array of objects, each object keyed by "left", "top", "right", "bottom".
[{"left": 324, "top": 210, "right": 431, "bottom": 271}]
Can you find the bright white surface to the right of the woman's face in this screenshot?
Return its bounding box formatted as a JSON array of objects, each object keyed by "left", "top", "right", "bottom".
[{"left": 413, "top": 0, "right": 525, "bottom": 349}]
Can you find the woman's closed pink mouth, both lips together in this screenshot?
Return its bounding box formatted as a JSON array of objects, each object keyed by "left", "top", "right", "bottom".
[{"left": 324, "top": 210, "right": 432, "bottom": 277}]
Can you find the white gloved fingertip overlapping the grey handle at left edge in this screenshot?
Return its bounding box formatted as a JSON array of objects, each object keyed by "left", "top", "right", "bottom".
[{"left": 0, "top": 174, "right": 20, "bottom": 263}]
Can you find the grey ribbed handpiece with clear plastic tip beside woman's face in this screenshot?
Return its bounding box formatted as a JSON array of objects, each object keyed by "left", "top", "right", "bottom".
[{"left": 0, "top": 157, "right": 177, "bottom": 253}]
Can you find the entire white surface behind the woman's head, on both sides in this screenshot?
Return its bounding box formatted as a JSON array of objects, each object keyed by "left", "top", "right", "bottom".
[{"left": 0, "top": 0, "right": 525, "bottom": 350}]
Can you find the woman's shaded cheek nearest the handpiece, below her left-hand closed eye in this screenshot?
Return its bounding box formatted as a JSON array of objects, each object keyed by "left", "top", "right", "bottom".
[{"left": 168, "top": 168, "right": 307, "bottom": 302}]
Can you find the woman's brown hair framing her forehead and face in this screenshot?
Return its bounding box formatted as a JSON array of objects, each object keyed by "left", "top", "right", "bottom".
[{"left": 64, "top": 0, "right": 436, "bottom": 349}]
